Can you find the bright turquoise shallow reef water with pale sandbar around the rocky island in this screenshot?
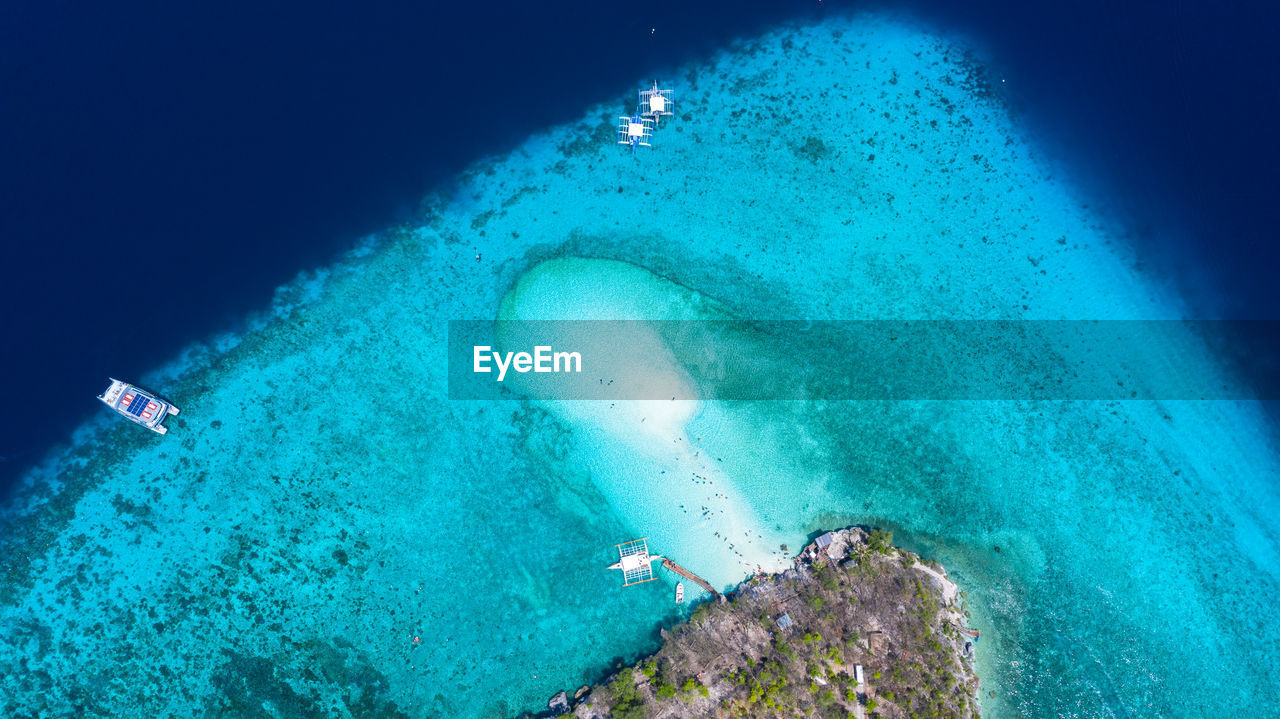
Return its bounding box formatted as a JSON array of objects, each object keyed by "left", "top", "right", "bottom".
[{"left": 0, "top": 17, "right": 1280, "bottom": 716}]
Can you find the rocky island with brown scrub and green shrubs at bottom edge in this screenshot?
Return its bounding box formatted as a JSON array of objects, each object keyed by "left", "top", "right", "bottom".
[{"left": 549, "top": 527, "right": 979, "bottom": 719}]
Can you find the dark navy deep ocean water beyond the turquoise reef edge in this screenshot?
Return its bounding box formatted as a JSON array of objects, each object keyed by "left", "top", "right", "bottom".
[{"left": 0, "top": 0, "right": 1280, "bottom": 482}]
